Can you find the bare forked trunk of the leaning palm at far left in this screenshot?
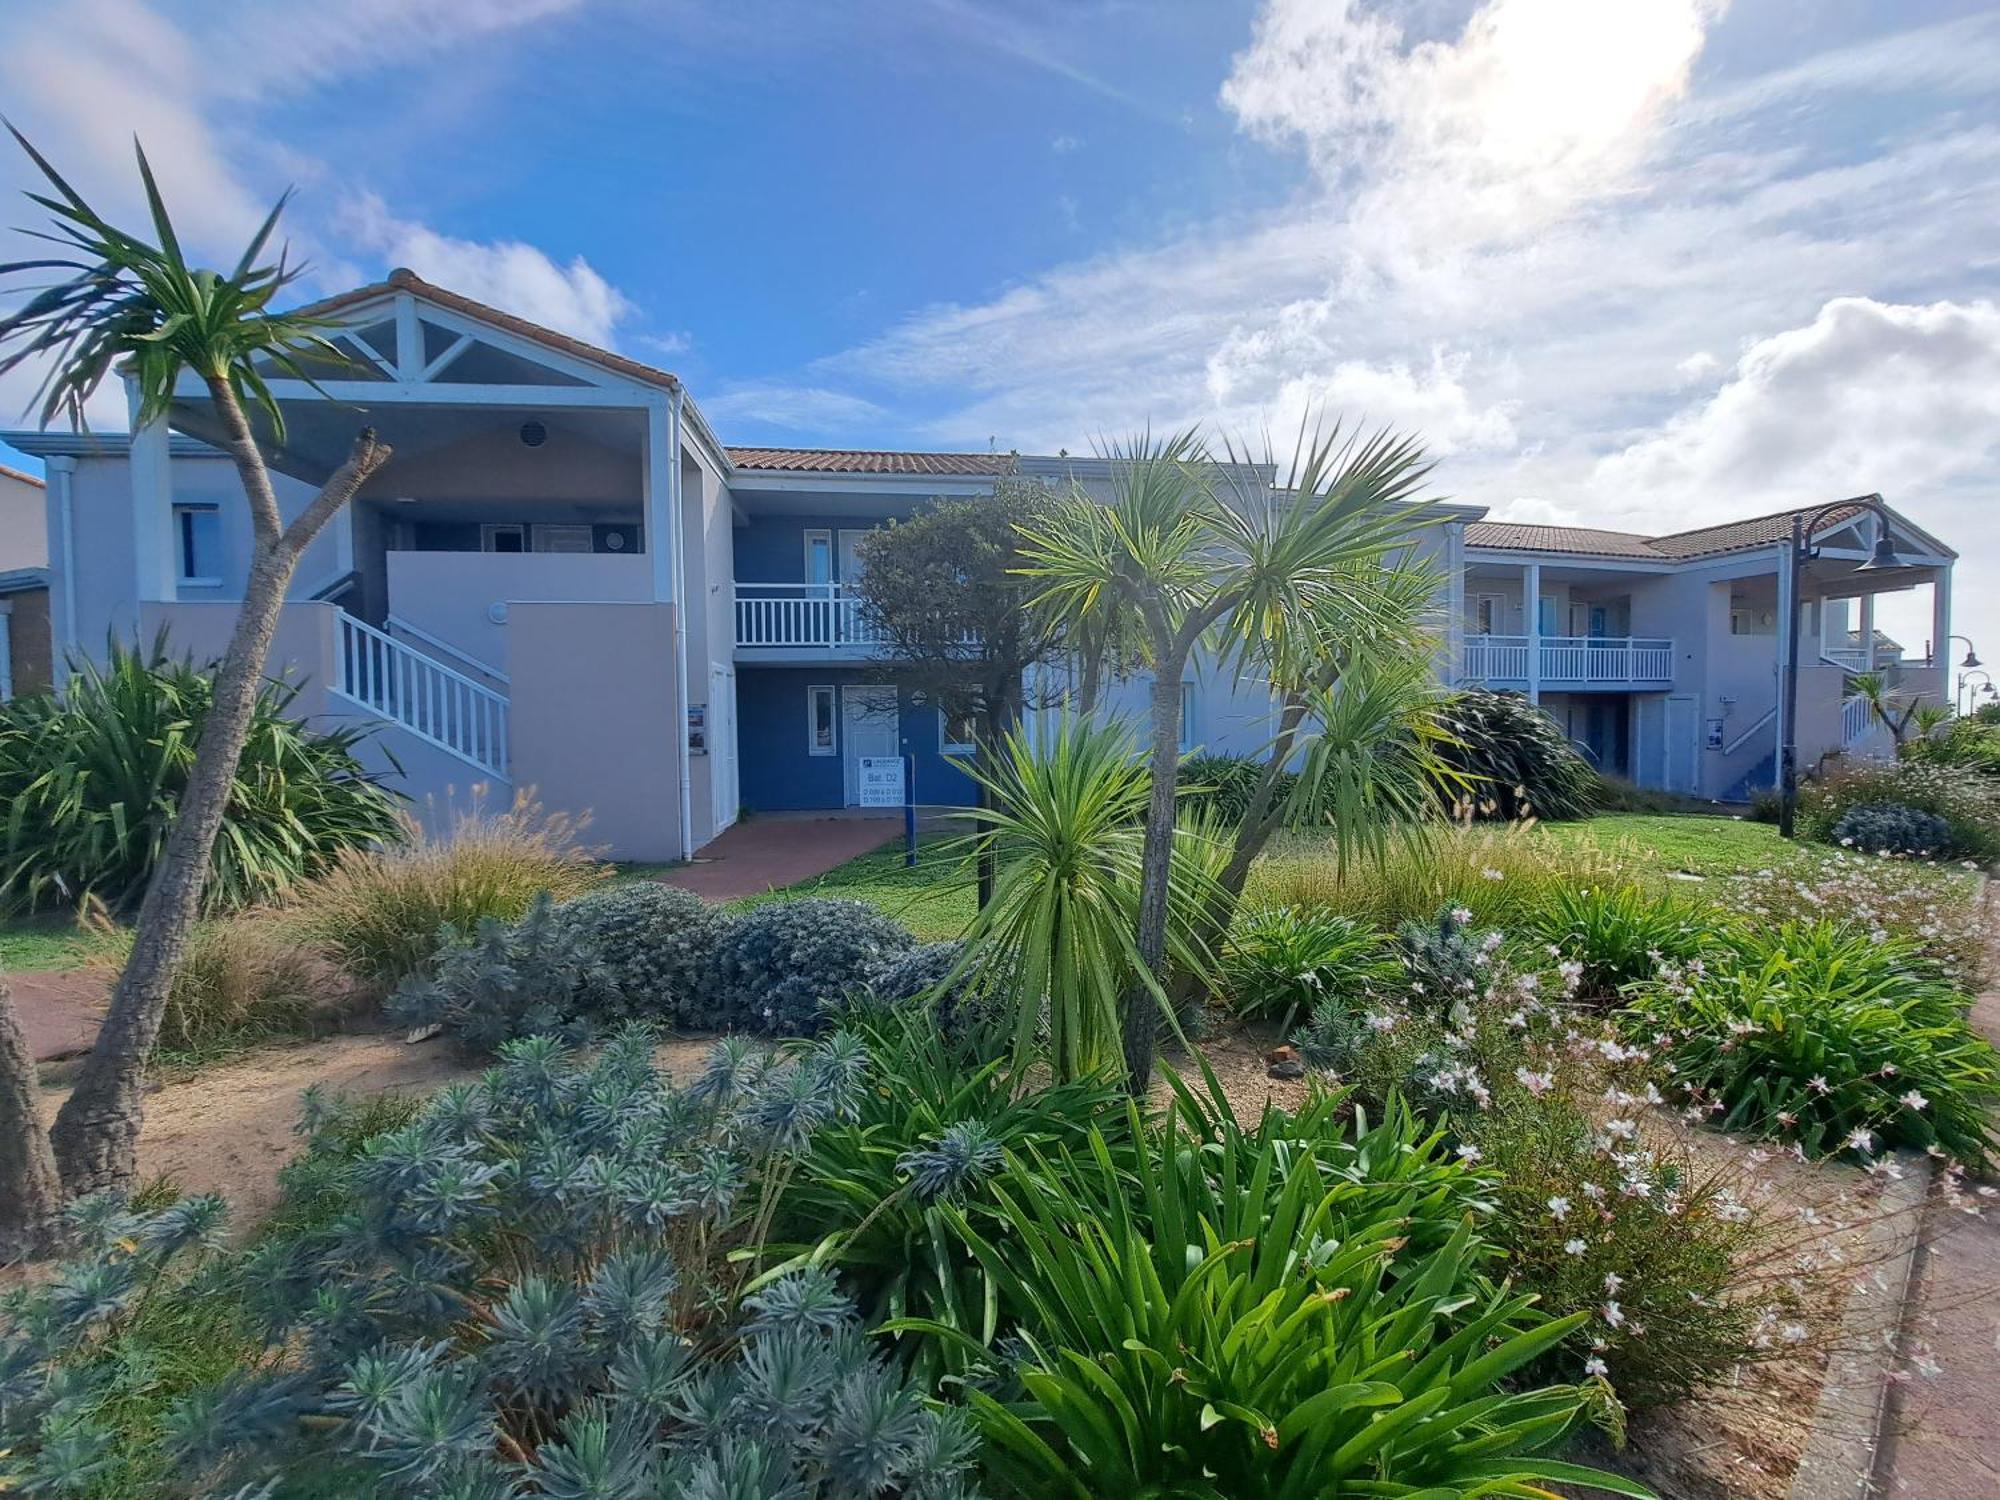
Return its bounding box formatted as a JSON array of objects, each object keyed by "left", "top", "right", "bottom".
[{"left": 50, "top": 406, "right": 388, "bottom": 1196}]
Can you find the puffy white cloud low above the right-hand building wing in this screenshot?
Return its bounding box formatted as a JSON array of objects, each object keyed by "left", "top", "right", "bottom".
[{"left": 1592, "top": 296, "right": 2000, "bottom": 524}]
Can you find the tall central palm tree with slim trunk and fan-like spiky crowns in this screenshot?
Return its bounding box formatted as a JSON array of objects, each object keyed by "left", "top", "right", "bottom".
[{"left": 1022, "top": 426, "right": 1430, "bottom": 1092}]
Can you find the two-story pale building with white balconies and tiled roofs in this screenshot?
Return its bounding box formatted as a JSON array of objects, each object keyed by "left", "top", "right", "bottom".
[{"left": 6, "top": 272, "right": 1952, "bottom": 858}]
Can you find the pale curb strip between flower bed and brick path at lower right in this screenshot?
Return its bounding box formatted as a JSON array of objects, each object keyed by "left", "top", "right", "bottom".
[{"left": 1786, "top": 1152, "right": 1932, "bottom": 1500}]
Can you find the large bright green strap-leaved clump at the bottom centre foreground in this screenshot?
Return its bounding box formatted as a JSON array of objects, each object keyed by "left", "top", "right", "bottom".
[{"left": 890, "top": 1096, "right": 1646, "bottom": 1500}]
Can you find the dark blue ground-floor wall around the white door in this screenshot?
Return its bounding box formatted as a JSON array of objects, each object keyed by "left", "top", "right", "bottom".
[{"left": 736, "top": 664, "right": 978, "bottom": 812}]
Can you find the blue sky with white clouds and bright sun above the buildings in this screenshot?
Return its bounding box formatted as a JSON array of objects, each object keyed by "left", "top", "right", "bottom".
[{"left": 0, "top": 0, "right": 2000, "bottom": 656}]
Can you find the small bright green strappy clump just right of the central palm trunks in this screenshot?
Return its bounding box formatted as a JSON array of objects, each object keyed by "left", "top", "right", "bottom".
[{"left": 1222, "top": 906, "right": 1402, "bottom": 1016}]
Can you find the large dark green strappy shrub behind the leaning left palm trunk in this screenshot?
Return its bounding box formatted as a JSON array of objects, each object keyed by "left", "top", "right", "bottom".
[{"left": 0, "top": 636, "right": 402, "bottom": 912}]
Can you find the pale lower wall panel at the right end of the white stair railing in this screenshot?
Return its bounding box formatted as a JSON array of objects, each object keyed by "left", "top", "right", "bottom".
[{"left": 508, "top": 604, "right": 686, "bottom": 860}]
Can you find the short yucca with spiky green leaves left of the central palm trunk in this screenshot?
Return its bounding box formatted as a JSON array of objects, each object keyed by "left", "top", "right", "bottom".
[{"left": 944, "top": 716, "right": 1210, "bottom": 1080}]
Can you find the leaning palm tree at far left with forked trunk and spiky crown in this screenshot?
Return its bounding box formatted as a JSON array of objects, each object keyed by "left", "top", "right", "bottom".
[{"left": 0, "top": 126, "right": 390, "bottom": 1224}]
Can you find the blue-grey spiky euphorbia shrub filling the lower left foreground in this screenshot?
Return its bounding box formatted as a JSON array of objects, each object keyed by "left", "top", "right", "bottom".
[{"left": 0, "top": 1030, "right": 976, "bottom": 1500}]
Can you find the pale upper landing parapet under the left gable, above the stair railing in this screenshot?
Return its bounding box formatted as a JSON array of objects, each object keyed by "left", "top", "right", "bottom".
[{"left": 386, "top": 552, "right": 652, "bottom": 672}]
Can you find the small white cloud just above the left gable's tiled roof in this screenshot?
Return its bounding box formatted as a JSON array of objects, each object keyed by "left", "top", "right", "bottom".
[{"left": 342, "top": 194, "right": 632, "bottom": 348}]
